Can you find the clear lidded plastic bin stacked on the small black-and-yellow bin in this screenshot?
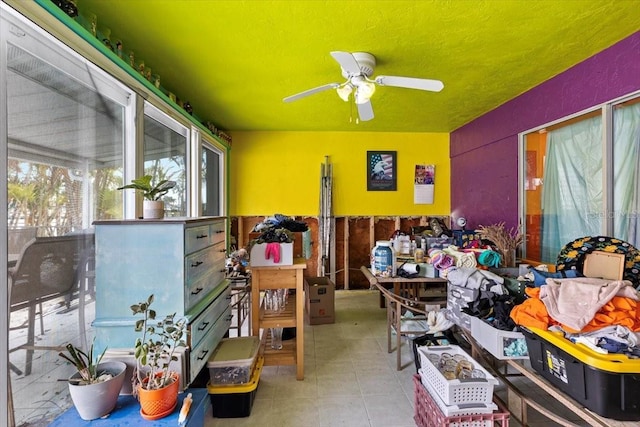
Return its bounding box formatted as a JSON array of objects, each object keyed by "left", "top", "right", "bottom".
[{"left": 207, "top": 337, "right": 260, "bottom": 385}]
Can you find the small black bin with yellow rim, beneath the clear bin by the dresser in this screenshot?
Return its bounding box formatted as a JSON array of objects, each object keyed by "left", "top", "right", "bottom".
[{"left": 207, "top": 357, "right": 264, "bottom": 418}]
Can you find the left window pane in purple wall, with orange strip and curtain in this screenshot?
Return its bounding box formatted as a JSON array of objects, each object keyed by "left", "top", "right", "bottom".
[{"left": 523, "top": 111, "right": 604, "bottom": 264}]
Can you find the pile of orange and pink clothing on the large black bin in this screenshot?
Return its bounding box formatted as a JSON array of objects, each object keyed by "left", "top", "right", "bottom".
[{"left": 510, "top": 277, "right": 640, "bottom": 356}]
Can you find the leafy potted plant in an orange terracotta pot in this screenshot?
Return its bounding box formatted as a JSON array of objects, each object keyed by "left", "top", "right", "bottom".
[{"left": 131, "top": 295, "right": 187, "bottom": 420}]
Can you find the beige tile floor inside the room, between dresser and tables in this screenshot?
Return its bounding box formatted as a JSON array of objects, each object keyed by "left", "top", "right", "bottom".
[{"left": 205, "top": 290, "right": 587, "bottom": 427}]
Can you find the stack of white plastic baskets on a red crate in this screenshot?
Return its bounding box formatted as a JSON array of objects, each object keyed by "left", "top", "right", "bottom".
[{"left": 414, "top": 345, "right": 509, "bottom": 427}]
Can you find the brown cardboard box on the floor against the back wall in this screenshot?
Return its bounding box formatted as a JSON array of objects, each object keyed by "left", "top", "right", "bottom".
[{"left": 304, "top": 277, "right": 336, "bottom": 325}]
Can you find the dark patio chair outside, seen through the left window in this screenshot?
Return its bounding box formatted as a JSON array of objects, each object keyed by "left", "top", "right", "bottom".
[{"left": 7, "top": 234, "right": 93, "bottom": 375}]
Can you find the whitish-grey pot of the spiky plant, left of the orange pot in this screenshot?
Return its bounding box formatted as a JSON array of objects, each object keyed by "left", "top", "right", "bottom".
[{"left": 69, "top": 361, "right": 127, "bottom": 420}]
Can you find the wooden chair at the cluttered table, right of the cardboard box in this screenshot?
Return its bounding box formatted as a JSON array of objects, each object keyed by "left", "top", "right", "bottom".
[{"left": 375, "top": 283, "right": 441, "bottom": 371}]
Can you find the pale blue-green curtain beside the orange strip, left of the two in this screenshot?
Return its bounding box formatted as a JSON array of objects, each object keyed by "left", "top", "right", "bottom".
[{"left": 541, "top": 116, "right": 603, "bottom": 264}]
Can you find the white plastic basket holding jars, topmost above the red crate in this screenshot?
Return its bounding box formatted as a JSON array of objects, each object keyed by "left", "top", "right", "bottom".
[{"left": 418, "top": 345, "right": 498, "bottom": 405}]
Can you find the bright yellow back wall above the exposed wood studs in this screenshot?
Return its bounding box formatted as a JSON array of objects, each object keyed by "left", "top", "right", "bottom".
[{"left": 229, "top": 132, "right": 451, "bottom": 216}]
